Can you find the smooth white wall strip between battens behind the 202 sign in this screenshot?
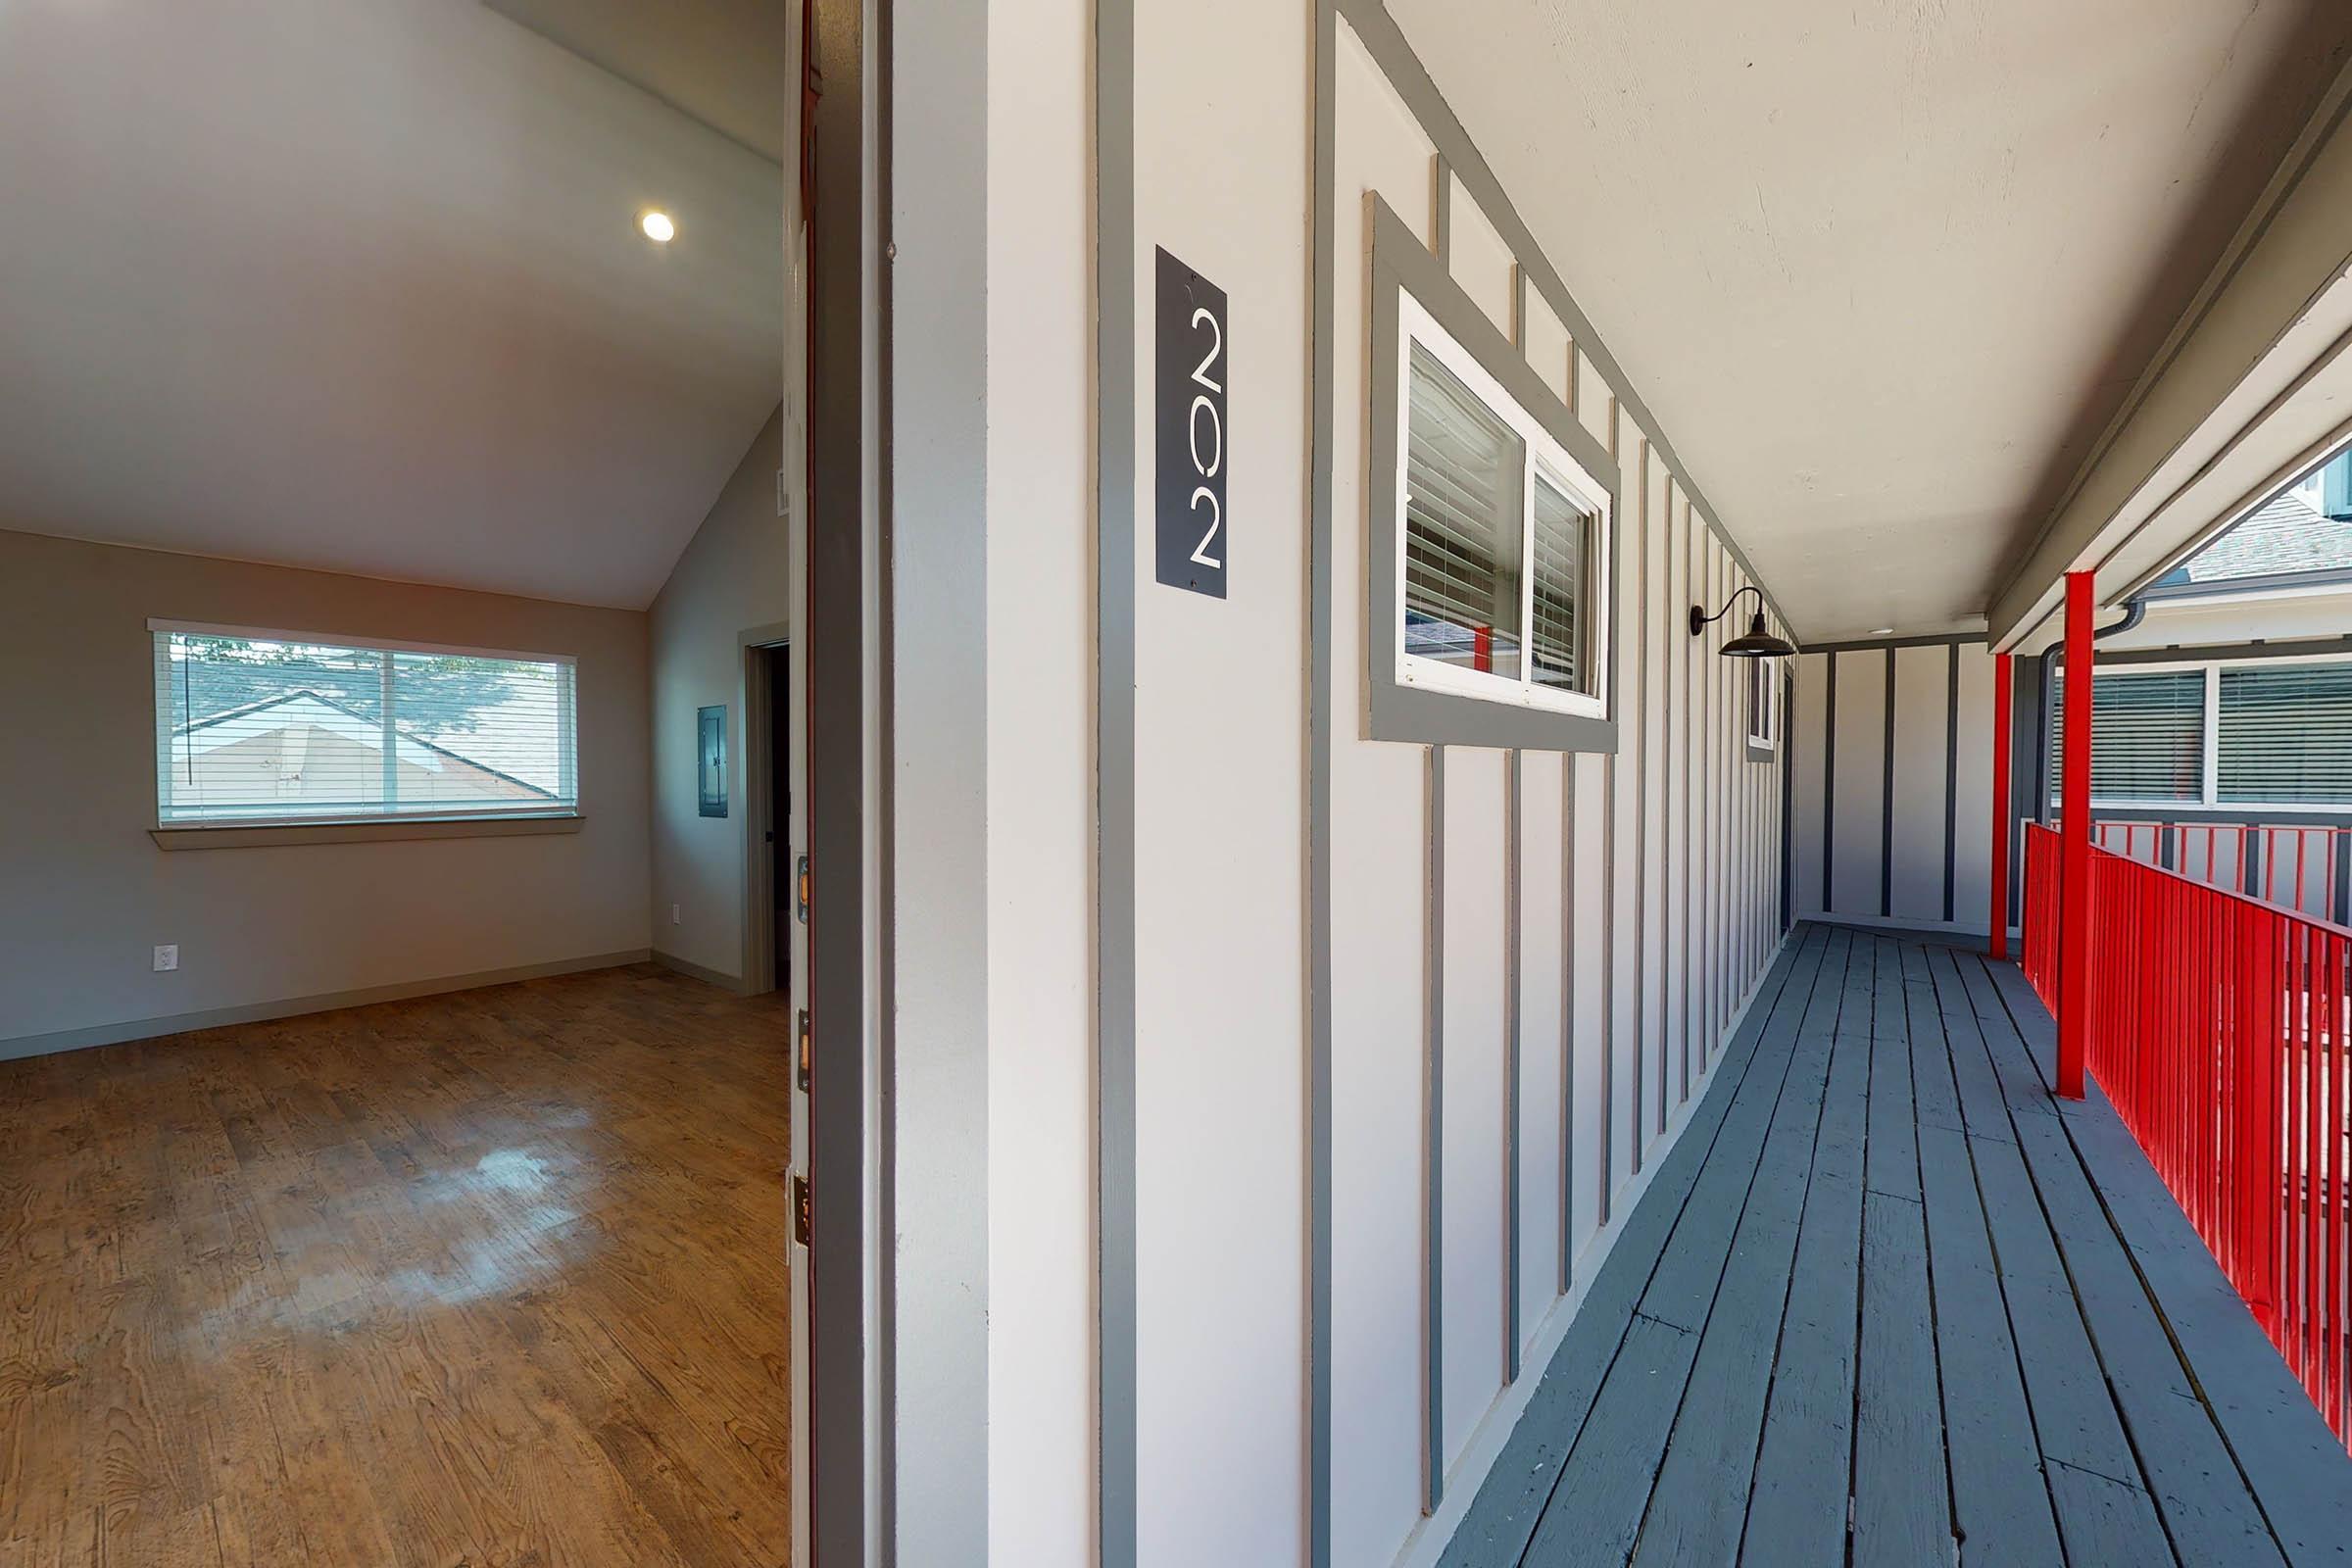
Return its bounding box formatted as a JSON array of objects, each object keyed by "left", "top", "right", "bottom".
[{"left": 1134, "top": 0, "right": 1312, "bottom": 1568}]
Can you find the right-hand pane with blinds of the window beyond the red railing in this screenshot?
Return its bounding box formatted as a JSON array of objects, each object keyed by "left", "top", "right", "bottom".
[{"left": 2216, "top": 662, "right": 2352, "bottom": 807}]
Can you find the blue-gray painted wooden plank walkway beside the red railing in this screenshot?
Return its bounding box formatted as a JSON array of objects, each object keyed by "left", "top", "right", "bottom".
[{"left": 1442, "top": 926, "right": 2352, "bottom": 1568}]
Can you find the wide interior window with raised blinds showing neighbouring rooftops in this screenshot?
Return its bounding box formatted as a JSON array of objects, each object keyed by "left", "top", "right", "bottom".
[{"left": 151, "top": 623, "right": 578, "bottom": 827}]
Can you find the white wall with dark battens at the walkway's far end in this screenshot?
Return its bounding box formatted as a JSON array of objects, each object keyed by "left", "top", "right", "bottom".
[{"left": 1789, "top": 637, "right": 1992, "bottom": 936}]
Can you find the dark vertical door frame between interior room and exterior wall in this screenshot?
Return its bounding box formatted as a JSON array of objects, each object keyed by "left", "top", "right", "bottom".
[{"left": 808, "top": 0, "right": 894, "bottom": 1568}]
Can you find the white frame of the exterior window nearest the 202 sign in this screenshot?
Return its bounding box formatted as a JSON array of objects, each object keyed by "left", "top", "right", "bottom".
[{"left": 1376, "top": 287, "right": 1613, "bottom": 719}]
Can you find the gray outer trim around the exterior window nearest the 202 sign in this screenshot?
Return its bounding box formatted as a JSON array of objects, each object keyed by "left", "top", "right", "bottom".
[{"left": 1364, "top": 195, "right": 1623, "bottom": 753}]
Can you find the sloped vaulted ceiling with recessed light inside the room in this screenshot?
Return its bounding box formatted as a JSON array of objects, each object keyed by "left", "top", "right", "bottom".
[{"left": 0, "top": 0, "right": 790, "bottom": 607}]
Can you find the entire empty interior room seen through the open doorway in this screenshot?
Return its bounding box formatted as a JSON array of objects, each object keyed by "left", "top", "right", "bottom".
[{"left": 0, "top": 0, "right": 800, "bottom": 1566}]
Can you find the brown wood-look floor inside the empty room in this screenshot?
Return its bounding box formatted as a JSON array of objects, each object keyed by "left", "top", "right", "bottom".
[{"left": 0, "top": 966, "right": 790, "bottom": 1568}]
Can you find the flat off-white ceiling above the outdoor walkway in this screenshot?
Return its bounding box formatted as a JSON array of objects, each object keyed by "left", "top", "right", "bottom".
[{"left": 1388, "top": 0, "right": 2352, "bottom": 639}]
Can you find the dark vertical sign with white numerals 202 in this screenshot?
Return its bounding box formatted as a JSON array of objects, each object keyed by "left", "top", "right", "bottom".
[{"left": 1152, "top": 249, "right": 1233, "bottom": 600}]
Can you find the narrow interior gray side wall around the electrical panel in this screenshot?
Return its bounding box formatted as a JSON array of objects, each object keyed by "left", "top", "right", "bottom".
[{"left": 647, "top": 409, "right": 800, "bottom": 978}]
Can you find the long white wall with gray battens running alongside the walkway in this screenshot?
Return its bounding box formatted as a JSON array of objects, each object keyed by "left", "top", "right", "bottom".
[{"left": 1317, "top": 5, "right": 1783, "bottom": 1566}]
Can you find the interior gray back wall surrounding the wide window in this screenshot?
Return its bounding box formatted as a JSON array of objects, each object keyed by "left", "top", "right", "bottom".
[{"left": 0, "top": 531, "right": 649, "bottom": 1055}]
